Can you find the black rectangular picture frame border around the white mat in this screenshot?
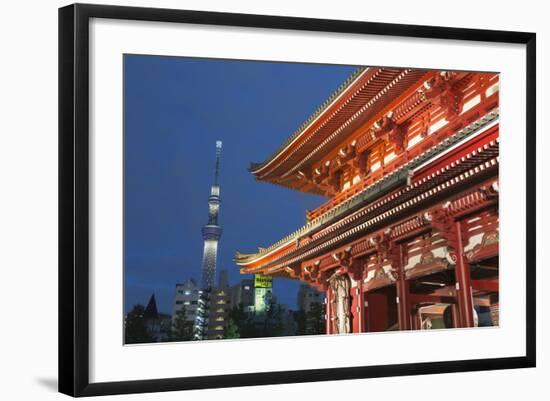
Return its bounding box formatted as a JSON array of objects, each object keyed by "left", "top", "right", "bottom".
[{"left": 59, "top": 4, "right": 536, "bottom": 396}]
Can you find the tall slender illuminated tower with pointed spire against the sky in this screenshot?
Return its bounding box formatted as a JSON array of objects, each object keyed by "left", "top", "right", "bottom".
[{"left": 196, "top": 141, "right": 222, "bottom": 339}]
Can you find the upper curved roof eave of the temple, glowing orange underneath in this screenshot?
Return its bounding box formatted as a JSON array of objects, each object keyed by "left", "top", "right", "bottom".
[{"left": 250, "top": 67, "right": 433, "bottom": 194}]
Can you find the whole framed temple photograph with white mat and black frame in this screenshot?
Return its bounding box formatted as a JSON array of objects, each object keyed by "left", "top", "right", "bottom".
[{"left": 59, "top": 4, "right": 536, "bottom": 396}]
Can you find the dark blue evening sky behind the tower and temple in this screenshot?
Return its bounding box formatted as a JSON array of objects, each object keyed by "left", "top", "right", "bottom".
[{"left": 124, "top": 55, "right": 355, "bottom": 313}]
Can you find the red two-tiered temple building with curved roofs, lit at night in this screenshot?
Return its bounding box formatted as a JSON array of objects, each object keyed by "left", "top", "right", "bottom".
[{"left": 235, "top": 67, "right": 499, "bottom": 334}]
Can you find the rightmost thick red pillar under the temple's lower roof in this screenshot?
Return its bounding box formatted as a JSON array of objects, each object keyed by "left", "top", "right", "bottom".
[{"left": 455, "top": 221, "right": 474, "bottom": 327}]
